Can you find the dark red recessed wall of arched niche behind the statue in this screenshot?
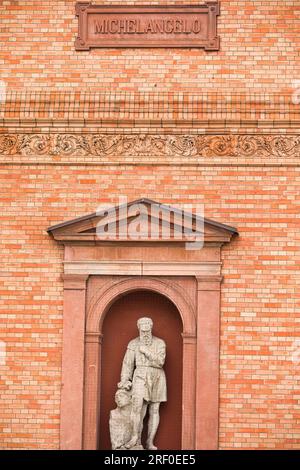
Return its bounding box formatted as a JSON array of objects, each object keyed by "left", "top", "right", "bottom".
[{"left": 98, "top": 290, "right": 183, "bottom": 450}]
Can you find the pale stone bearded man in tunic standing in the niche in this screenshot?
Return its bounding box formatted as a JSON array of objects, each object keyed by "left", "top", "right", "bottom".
[{"left": 112, "top": 317, "right": 167, "bottom": 450}]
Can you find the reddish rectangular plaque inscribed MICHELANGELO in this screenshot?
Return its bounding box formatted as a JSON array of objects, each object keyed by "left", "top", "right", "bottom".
[{"left": 75, "top": 1, "right": 220, "bottom": 51}]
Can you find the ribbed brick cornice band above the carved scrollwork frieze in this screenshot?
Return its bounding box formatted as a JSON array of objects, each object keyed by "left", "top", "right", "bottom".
[{"left": 0, "top": 89, "right": 300, "bottom": 124}]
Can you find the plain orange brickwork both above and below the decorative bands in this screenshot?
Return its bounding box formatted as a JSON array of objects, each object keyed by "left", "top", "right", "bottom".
[{"left": 0, "top": 0, "right": 300, "bottom": 449}]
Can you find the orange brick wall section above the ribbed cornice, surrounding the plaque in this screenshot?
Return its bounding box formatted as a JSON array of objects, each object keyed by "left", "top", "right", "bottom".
[{"left": 0, "top": 0, "right": 300, "bottom": 92}]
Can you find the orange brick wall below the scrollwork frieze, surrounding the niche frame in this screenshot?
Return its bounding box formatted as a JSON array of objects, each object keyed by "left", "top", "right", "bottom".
[{"left": 1, "top": 166, "right": 300, "bottom": 448}]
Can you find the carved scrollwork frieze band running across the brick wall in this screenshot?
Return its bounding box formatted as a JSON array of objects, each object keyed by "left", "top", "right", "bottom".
[{"left": 0, "top": 134, "right": 300, "bottom": 158}]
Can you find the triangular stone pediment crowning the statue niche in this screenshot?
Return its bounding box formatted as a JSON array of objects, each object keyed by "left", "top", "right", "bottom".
[{"left": 47, "top": 199, "right": 238, "bottom": 243}]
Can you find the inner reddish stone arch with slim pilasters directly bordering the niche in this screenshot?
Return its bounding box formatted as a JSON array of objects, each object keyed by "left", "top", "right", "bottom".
[{"left": 83, "top": 277, "right": 196, "bottom": 449}]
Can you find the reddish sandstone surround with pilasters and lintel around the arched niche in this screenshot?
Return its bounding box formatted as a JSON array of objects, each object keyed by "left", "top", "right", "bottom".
[{"left": 48, "top": 196, "right": 237, "bottom": 450}]
